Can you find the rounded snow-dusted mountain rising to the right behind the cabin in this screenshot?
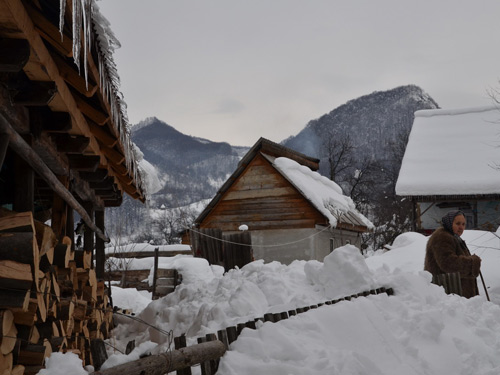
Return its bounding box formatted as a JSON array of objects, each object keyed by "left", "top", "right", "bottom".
[{"left": 282, "top": 85, "right": 439, "bottom": 175}]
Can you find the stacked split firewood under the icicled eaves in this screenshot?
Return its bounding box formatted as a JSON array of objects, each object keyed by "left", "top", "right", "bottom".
[{"left": 0, "top": 210, "right": 113, "bottom": 375}]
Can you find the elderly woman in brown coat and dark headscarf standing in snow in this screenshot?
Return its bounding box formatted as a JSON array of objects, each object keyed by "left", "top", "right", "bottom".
[{"left": 424, "top": 211, "right": 481, "bottom": 298}]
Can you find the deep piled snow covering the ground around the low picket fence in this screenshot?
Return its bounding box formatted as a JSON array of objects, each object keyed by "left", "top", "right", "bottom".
[{"left": 40, "top": 231, "right": 500, "bottom": 375}]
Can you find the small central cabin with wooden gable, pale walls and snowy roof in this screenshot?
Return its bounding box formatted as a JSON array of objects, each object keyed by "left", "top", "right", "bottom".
[{"left": 192, "top": 138, "right": 372, "bottom": 264}]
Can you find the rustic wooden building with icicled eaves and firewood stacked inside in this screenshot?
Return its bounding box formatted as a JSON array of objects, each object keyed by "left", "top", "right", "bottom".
[{"left": 0, "top": 0, "right": 145, "bottom": 374}]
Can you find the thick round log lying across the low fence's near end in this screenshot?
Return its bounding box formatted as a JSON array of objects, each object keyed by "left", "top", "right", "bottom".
[{"left": 94, "top": 340, "right": 226, "bottom": 375}]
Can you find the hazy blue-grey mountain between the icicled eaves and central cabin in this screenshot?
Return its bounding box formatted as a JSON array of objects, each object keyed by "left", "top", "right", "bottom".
[{"left": 132, "top": 117, "right": 248, "bottom": 207}]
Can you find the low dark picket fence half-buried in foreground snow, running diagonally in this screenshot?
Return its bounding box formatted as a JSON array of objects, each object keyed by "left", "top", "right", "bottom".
[{"left": 170, "top": 288, "right": 394, "bottom": 375}]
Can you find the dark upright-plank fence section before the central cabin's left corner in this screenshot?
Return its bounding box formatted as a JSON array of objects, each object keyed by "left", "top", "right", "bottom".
[{"left": 190, "top": 228, "right": 253, "bottom": 271}]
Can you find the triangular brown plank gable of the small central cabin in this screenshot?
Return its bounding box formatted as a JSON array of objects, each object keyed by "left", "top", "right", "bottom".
[{"left": 199, "top": 153, "right": 328, "bottom": 231}]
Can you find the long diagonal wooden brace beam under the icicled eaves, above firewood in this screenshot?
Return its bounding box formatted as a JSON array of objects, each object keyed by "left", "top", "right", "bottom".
[{"left": 0, "top": 113, "right": 109, "bottom": 242}]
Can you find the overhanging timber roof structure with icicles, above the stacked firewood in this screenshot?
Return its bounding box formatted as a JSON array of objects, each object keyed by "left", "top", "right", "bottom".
[{"left": 0, "top": 0, "right": 145, "bottom": 278}]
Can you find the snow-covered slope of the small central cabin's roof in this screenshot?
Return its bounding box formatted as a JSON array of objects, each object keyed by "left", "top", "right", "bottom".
[{"left": 272, "top": 155, "right": 373, "bottom": 229}]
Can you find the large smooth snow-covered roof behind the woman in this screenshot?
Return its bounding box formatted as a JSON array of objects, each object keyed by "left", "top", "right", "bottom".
[{"left": 396, "top": 106, "right": 500, "bottom": 196}]
